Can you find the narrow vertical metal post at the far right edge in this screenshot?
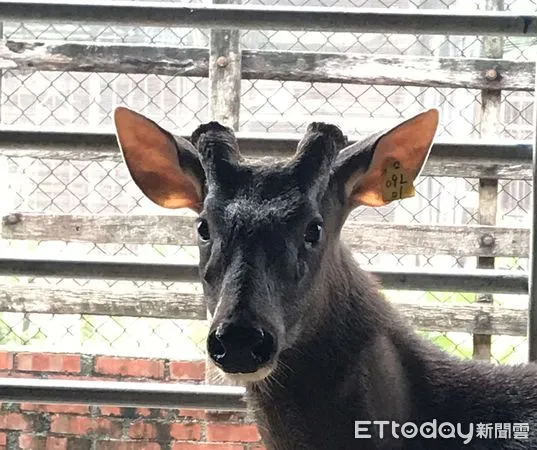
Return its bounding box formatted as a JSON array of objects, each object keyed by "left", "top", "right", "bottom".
[{"left": 528, "top": 56, "right": 537, "bottom": 362}]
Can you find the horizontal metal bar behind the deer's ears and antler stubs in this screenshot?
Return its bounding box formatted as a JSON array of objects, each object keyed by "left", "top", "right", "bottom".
[{"left": 0, "top": 128, "right": 533, "bottom": 162}]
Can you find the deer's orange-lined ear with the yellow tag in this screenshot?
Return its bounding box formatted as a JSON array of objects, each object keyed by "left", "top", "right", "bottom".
[{"left": 338, "top": 109, "right": 439, "bottom": 208}]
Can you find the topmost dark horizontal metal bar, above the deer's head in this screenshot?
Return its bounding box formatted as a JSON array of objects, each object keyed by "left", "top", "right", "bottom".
[{"left": 0, "top": 0, "right": 537, "bottom": 36}]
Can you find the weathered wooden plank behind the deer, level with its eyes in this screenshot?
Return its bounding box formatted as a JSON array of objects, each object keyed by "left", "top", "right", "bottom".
[{"left": 0, "top": 213, "right": 529, "bottom": 257}]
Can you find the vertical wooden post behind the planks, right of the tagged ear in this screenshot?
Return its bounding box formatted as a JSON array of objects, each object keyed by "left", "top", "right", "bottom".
[{"left": 473, "top": 0, "right": 503, "bottom": 360}]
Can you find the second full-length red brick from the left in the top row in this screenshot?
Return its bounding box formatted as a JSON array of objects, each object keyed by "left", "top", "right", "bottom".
[{"left": 95, "top": 356, "right": 164, "bottom": 378}]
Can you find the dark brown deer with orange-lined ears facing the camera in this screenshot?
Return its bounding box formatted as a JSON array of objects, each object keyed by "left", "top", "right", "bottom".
[{"left": 113, "top": 106, "right": 537, "bottom": 450}]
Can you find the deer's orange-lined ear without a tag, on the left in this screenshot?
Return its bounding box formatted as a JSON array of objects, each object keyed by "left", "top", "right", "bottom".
[{"left": 114, "top": 107, "right": 205, "bottom": 213}]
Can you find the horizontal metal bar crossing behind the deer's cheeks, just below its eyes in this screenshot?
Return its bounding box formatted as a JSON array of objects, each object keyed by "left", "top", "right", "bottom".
[{"left": 0, "top": 258, "right": 528, "bottom": 294}]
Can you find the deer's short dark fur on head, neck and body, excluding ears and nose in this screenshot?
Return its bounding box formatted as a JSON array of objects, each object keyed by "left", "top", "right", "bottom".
[{"left": 139, "top": 118, "right": 537, "bottom": 450}]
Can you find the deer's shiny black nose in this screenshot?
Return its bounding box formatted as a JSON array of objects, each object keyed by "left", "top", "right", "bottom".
[{"left": 207, "top": 323, "right": 275, "bottom": 373}]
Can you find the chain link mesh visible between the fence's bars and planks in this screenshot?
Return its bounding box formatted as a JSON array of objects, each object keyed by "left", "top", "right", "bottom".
[{"left": 0, "top": 0, "right": 537, "bottom": 363}]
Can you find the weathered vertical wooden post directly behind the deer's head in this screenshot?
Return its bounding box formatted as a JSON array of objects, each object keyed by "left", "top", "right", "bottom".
[{"left": 205, "top": 0, "right": 241, "bottom": 385}]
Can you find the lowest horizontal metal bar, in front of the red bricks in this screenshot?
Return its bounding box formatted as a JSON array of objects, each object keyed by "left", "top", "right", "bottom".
[{"left": 0, "top": 378, "right": 246, "bottom": 411}]
